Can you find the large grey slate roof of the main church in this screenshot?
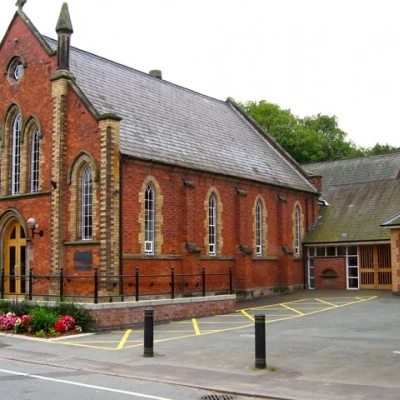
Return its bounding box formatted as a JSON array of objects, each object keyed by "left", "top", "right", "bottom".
[{"left": 45, "top": 38, "right": 316, "bottom": 193}]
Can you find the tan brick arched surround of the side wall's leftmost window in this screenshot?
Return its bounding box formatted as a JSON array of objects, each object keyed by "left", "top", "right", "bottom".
[{"left": 138, "top": 175, "right": 164, "bottom": 254}]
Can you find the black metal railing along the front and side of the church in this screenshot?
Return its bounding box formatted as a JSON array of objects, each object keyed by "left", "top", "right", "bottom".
[{"left": 0, "top": 267, "right": 233, "bottom": 304}]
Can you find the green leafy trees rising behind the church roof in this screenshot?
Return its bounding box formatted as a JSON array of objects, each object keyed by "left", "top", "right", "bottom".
[{"left": 241, "top": 100, "right": 400, "bottom": 164}]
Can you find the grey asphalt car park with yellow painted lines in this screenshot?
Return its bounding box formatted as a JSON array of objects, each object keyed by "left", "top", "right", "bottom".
[{"left": 0, "top": 291, "right": 400, "bottom": 400}]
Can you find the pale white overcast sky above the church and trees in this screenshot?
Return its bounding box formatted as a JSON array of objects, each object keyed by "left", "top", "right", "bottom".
[{"left": 0, "top": 0, "right": 400, "bottom": 147}]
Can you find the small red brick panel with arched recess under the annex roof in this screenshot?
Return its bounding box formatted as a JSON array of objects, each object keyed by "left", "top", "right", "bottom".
[{"left": 314, "top": 257, "right": 346, "bottom": 289}]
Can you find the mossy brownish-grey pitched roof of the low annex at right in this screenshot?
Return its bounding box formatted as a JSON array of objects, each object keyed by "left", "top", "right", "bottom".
[{"left": 304, "top": 153, "right": 400, "bottom": 244}]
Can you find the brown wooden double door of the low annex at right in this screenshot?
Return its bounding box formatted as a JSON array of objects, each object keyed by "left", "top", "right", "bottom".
[{"left": 359, "top": 244, "right": 392, "bottom": 289}]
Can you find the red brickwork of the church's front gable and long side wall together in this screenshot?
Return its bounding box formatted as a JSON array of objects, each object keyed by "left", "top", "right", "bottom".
[{"left": 0, "top": 18, "right": 318, "bottom": 294}]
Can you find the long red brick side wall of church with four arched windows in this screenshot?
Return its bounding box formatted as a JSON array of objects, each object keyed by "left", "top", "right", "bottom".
[{"left": 122, "top": 161, "right": 317, "bottom": 290}]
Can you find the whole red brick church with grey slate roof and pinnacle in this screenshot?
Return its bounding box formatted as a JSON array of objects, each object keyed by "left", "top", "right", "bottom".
[{"left": 0, "top": 2, "right": 318, "bottom": 297}]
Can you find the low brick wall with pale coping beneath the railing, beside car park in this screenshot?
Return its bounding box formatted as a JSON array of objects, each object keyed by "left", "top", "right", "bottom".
[{"left": 80, "top": 295, "right": 236, "bottom": 330}]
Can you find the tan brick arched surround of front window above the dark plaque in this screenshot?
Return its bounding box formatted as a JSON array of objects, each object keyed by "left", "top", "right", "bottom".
[{"left": 68, "top": 151, "right": 99, "bottom": 240}]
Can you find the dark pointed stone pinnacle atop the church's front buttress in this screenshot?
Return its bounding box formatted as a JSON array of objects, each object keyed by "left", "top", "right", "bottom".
[{"left": 56, "top": 3, "right": 73, "bottom": 71}]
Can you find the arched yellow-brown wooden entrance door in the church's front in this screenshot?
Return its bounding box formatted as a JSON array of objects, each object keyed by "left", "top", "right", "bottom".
[{"left": 4, "top": 222, "right": 27, "bottom": 297}]
